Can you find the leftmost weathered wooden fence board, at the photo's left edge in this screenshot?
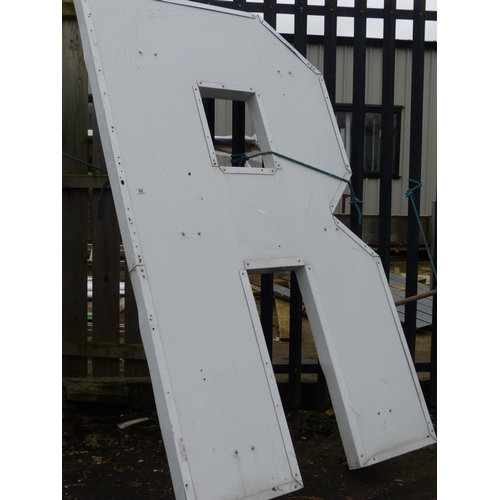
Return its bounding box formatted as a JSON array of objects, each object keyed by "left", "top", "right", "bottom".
[{"left": 62, "top": 11, "right": 88, "bottom": 377}]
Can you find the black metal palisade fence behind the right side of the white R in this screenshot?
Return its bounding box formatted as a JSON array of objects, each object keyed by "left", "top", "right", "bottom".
[{"left": 193, "top": 0, "right": 437, "bottom": 401}]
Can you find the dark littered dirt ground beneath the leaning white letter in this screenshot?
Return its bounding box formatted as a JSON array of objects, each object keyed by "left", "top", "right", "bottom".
[{"left": 62, "top": 388, "right": 437, "bottom": 500}]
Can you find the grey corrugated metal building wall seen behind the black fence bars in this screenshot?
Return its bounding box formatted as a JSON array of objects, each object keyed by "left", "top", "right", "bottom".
[{"left": 215, "top": 43, "right": 437, "bottom": 216}]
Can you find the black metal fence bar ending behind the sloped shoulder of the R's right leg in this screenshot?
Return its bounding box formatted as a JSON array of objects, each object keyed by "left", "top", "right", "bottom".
[{"left": 378, "top": 0, "right": 396, "bottom": 278}]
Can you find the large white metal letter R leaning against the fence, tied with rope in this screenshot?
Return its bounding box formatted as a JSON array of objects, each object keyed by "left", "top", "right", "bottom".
[{"left": 75, "top": 0, "right": 435, "bottom": 500}]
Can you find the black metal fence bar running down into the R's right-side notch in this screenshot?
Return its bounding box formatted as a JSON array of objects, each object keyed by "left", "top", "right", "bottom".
[{"left": 350, "top": 0, "right": 366, "bottom": 238}]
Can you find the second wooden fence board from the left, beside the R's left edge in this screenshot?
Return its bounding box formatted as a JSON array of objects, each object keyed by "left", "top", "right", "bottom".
[{"left": 92, "top": 124, "right": 121, "bottom": 377}]
